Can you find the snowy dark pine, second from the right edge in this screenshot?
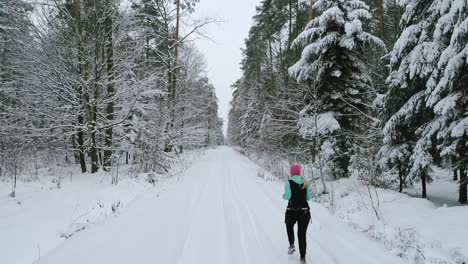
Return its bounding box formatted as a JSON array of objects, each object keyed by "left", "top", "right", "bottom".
[{"left": 380, "top": 0, "right": 444, "bottom": 197}]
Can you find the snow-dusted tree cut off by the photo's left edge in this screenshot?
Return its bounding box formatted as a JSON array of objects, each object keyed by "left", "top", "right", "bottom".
[{"left": 0, "top": 0, "right": 33, "bottom": 190}]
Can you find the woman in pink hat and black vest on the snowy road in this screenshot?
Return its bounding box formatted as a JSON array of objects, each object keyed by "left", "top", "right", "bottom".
[{"left": 283, "top": 164, "right": 311, "bottom": 263}]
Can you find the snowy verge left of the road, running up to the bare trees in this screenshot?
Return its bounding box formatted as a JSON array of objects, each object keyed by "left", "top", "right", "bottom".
[{"left": 0, "top": 148, "right": 202, "bottom": 264}]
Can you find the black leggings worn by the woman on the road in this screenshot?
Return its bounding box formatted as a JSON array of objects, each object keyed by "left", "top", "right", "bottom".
[{"left": 285, "top": 209, "right": 310, "bottom": 258}]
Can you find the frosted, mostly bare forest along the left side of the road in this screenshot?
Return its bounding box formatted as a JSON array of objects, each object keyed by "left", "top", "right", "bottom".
[{"left": 0, "top": 0, "right": 224, "bottom": 192}]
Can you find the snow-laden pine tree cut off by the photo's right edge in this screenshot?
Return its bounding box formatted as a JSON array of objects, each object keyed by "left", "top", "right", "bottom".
[{"left": 424, "top": 0, "right": 468, "bottom": 204}]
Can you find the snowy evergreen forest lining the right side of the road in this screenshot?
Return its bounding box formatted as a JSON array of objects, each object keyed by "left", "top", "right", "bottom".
[{"left": 227, "top": 0, "right": 468, "bottom": 204}]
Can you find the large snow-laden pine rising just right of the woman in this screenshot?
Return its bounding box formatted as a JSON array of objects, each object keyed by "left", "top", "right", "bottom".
[{"left": 290, "top": 0, "right": 384, "bottom": 178}]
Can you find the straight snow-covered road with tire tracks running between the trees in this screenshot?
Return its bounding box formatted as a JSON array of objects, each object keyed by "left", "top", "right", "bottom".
[{"left": 38, "top": 147, "right": 404, "bottom": 264}]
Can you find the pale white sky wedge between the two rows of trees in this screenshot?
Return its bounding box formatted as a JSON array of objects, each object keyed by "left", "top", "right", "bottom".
[{"left": 195, "top": 0, "right": 260, "bottom": 134}]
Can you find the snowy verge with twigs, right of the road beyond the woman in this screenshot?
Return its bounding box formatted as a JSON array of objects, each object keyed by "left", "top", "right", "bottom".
[{"left": 319, "top": 175, "right": 468, "bottom": 264}]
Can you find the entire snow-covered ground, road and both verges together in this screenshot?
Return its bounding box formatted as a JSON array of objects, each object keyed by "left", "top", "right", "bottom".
[{"left": 0, "top": 147, "right": 468, "bottom": 264}]
